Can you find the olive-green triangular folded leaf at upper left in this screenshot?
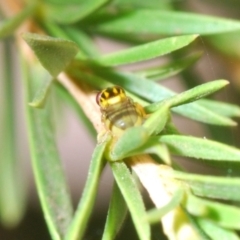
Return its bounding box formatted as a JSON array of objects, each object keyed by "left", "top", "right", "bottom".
[{"left": 23, "top": 33, "right": 79, "bottom": 77}]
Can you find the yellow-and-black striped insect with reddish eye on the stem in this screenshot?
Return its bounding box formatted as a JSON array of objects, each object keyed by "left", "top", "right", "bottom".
[{"left": 96, "top": 86, "right": 146, "bottom": 134}]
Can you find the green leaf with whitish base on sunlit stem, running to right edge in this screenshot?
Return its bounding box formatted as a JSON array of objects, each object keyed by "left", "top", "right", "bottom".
[{"left": 159, "top": 169, "right": 240, "bottom": 201}]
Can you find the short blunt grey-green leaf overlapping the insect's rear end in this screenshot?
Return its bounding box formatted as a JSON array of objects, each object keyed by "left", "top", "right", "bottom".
[{"left": 109, "top": 126, "right": 149, "bottom": 161}]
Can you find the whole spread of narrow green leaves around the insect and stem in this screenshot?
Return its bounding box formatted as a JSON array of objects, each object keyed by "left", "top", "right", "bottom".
[{"left": 0, "top": 0, "right": 240, "bottom": 240}]
